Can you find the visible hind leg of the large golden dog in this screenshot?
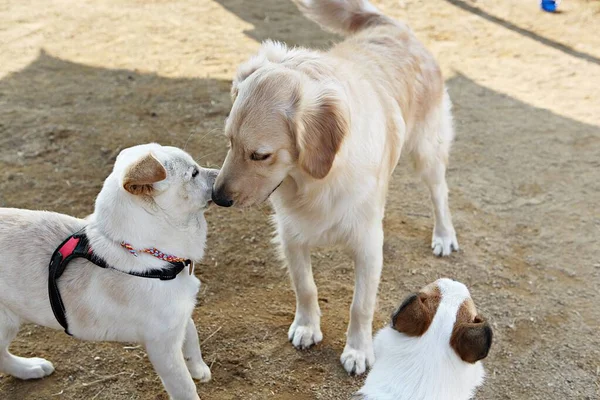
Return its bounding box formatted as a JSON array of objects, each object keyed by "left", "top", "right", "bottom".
[{"left": 412, "top": 94, "right": 458, "bottom": 256}]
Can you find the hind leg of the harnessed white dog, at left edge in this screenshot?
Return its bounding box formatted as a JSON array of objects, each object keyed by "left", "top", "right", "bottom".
[{"left": 0, "top": 309, "right": 54, "bottom": 379}]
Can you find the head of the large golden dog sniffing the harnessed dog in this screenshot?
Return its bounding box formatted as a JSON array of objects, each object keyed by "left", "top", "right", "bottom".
[{"left": 213, "top": 42, "right": 348, "bottom": 207}]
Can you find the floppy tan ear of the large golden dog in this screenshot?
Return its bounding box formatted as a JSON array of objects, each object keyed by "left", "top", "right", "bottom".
[{"left": 296, "top": 90, "right": 349, "bottom": 179}]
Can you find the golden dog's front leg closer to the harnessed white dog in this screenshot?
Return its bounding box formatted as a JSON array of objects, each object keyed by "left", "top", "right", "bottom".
[{"left": 282, "top": 239, "right": 323, "bottom": 349}]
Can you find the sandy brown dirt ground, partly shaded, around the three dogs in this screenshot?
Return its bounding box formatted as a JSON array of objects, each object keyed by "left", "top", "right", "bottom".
[{"left": 0, "top": 0, "right": 600, "bottom": 400}]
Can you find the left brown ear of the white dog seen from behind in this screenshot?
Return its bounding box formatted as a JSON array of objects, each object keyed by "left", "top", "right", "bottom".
[{"left": 392, "top": 293, "right": 439, "bottom": 336}]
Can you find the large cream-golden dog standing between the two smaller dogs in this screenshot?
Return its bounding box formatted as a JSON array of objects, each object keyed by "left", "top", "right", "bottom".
[{"left": 213, "top": 0, "right": 458, "bottom": 374}]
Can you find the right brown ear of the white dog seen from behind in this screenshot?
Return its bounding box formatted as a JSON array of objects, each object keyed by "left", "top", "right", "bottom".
[{"left": 450, "top": 315, "right": 493, "bottom": 363}]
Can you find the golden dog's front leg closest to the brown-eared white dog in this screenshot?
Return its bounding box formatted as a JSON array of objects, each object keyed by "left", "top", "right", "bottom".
[{"left": 340, "top": 220, "right": 383, "bottom": 375}]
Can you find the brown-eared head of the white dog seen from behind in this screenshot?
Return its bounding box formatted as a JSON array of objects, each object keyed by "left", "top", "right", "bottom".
[{"left": 391, "top": 279, "right": 493, "bottom": 363}]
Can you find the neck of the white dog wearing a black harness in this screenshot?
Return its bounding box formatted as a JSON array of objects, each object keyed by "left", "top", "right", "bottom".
[{"left": 86, "top": 183, "right": 206, "bottom": 272}]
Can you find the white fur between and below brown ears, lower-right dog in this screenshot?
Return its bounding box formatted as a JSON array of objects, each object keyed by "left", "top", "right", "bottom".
[{"left": 358, "top": 279, "right": 485, "bottom": 400}]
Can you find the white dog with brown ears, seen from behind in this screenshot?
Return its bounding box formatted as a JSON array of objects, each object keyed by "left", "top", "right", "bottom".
[{"left": 356, "top": 279, "right": 492, "bottom": 400}]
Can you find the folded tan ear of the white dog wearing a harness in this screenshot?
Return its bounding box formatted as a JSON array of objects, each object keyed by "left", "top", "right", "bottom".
[{"left": 123, "top": 153, "right": 167, "bottom": 195}]
